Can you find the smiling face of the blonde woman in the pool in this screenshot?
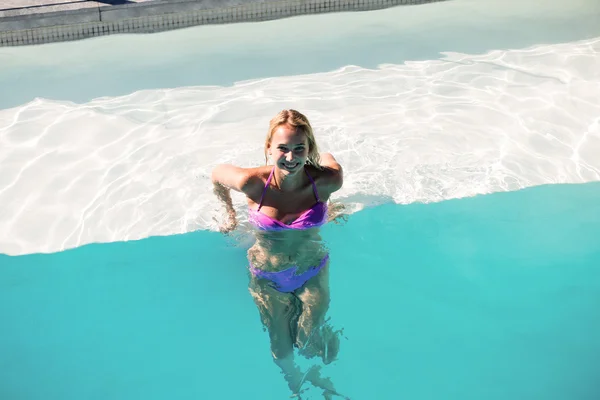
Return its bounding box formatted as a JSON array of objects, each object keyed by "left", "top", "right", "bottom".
[{"left": 269, "top": 125, "right": 309, "bottom": 174}]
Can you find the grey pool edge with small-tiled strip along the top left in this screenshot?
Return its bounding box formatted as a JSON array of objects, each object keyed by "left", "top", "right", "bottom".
[{"left": 0, "top": 0, "right": 445, "bottom": 47}]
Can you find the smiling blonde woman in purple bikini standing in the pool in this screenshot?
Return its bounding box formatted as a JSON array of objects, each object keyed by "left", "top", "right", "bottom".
[{"left": 212, "top": 110, "right": 343, "bottom": 398}]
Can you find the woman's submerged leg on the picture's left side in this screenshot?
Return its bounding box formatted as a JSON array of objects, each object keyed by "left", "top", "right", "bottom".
[{"left": 249, "top": 277, "right": 304, "bottom": 394}]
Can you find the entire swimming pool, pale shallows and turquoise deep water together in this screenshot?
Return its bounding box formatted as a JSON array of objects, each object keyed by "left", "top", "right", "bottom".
[{"left": 0, "top": 0, "right": 600, "bottom": 400}]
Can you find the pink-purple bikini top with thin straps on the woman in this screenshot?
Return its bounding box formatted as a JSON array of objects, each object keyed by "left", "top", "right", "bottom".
[{"left": 248, "top": 168, "right": 327, "bottom": 231}]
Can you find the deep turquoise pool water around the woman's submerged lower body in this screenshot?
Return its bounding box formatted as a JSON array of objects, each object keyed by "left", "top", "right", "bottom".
[{"left": 0, "top": 183, "right": 600, "bottom": 400}]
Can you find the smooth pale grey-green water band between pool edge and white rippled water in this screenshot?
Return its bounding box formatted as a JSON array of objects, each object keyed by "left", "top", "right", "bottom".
[{"left": 0, "top": 0, "right": 600, "bottom": 108}]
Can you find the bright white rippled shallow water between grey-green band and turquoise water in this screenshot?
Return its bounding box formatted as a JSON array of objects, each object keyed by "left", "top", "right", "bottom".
[{"left": 0, "top": 0, "right": 600, "bottom": 254}]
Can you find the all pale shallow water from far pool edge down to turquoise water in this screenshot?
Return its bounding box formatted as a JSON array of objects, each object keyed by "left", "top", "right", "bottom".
[{"left": 0, "top": 0, "right": 600, "bottom": 254}]
